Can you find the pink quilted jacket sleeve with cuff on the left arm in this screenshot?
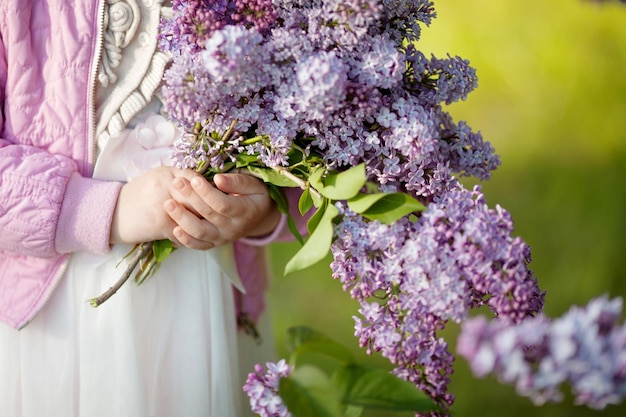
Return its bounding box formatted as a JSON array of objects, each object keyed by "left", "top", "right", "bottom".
[{"left": 0, "top": 37, "right": 122, "bottom": 257}]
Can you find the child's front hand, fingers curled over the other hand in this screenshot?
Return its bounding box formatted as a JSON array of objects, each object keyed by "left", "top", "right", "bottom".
[{"left": 164, "top": 174, "right": 280, "bottom": 249}]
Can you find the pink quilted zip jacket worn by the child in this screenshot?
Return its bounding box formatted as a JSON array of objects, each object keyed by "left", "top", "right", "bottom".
[{"left": 0, "top": 0, "right": 302, "bottom": 328}]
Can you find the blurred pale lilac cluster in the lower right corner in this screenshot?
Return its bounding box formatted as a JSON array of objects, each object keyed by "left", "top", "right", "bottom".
[{"left": 458, "top": 296, "right": 626, "bottom": 409}]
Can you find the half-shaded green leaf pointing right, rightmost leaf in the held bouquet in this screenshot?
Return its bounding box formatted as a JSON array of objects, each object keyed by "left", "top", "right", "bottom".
[{"left": 348, "top": 193, "right": 426, "bottom": 224}]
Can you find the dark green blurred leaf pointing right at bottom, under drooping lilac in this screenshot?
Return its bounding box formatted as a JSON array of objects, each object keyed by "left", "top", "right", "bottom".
[{"left": 333, "top": 364, "right": 439, "bottom": 413}]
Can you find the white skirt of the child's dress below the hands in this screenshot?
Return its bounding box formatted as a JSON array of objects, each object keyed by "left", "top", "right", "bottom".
[{"left": 0, "top": 246, "right": 273, "bottom": 417}]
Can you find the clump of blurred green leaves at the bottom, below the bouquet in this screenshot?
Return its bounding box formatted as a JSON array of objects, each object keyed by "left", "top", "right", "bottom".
[{"left": 279, "top": 326, "right": 438, "bottom": 417}]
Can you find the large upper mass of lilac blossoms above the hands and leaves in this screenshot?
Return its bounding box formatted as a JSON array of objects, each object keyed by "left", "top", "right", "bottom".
[{"left": 161, "top": 0, "right": 499, "bottom": 197}]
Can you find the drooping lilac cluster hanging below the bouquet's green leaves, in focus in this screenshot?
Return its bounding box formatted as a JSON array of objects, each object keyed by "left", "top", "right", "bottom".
[{"left": 331, "top": 187, "right": 544, "bottom": 412}]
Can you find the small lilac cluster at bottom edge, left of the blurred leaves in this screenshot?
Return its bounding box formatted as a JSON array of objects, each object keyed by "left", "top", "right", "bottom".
[{"left": 243, "top": 359, "right": 291, "bottom": 417}]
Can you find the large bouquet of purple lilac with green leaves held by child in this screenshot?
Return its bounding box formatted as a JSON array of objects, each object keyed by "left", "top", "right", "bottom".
[{"left": 92, "top": 0, "right": 543, "bottom": 416}]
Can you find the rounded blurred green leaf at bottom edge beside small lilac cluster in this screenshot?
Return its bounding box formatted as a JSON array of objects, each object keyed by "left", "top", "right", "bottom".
[{"left": 278, "top": 366, "right": 341, "bottom": 417}]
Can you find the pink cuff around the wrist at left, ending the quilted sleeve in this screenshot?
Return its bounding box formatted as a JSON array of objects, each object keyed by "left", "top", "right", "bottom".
[{"left": 55, "top": 173, "right": 123, "bottom": 254}]
